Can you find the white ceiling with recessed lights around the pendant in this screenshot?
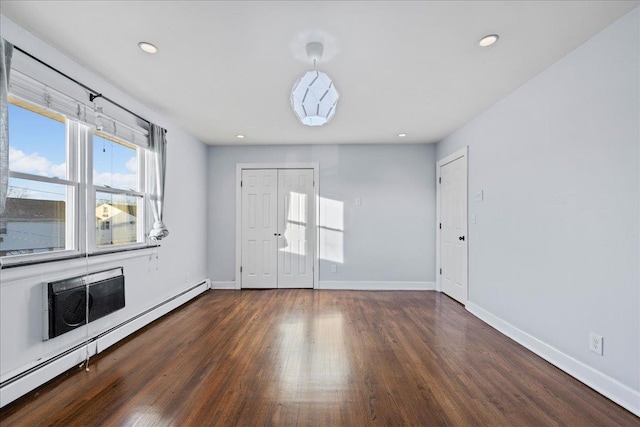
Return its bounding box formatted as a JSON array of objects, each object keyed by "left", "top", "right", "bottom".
[{"left": 0, "top": 0, "right": 640, "bottom": 145}]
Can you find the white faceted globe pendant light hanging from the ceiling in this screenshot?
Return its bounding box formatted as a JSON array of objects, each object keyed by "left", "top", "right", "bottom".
[{"left": 291, "top": 42, "right": 340, "bottom": 126}]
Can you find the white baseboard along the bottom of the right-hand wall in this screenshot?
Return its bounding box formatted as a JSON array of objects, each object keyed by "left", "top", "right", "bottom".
[{"left": 466, "top": 302, "right": 640, "bottom": 417}]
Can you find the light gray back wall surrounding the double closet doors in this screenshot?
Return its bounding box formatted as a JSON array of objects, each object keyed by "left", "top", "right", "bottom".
[{"left": 208, "top": 145, "right": 435, "bottom": 288}]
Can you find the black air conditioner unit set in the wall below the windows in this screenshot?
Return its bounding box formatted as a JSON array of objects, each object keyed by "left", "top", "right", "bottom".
[{"left": 45, "top": 267, "right": 125, "bottom": 339}]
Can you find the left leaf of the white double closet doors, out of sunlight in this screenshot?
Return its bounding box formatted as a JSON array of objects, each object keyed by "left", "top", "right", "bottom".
[{"left": 241, "top": 169, "right": 278, "bottom": 288}]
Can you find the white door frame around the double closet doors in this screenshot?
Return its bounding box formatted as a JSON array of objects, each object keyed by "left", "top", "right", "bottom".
[{"left": 235, "top": 162, "right": 320, "bottom": 290}]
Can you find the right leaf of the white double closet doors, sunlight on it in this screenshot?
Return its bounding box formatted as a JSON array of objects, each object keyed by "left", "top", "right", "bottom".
[{"left": 278, "top": 169, "right": 315, "bottom": 288}]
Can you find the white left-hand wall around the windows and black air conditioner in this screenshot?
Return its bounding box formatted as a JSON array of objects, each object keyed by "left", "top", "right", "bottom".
[{"left": 0, "top": 16, "right": 207, "bottom": 403}]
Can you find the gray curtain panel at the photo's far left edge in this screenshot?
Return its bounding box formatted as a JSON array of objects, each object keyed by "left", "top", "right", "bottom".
[{"left": 0, "top": 39, "right": 13, "bottom": 214}]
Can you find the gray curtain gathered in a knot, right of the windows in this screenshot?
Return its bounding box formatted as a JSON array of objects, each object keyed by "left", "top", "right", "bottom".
[{"left": 149, "top": 123, "right": 169, "bottom": 240}]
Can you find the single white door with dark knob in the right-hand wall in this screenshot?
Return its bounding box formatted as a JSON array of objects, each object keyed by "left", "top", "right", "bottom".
[{"left": 440, "top": 156, "right": 468, "bottom": 304}]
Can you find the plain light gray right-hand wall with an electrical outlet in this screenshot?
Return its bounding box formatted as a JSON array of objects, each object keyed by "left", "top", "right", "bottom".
[{"left": 437, "top": 8, "right": 640, "bottom": 390}]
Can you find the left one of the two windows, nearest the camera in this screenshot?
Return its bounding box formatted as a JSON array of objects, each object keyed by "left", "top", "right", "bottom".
[{"left": 0, "top": 99, "right": 78, "bottom": 256}]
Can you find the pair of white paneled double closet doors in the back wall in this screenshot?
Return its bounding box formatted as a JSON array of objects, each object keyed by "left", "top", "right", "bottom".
[{"left": 241, "top": 169, "right": 315, "bottom": 288}]
